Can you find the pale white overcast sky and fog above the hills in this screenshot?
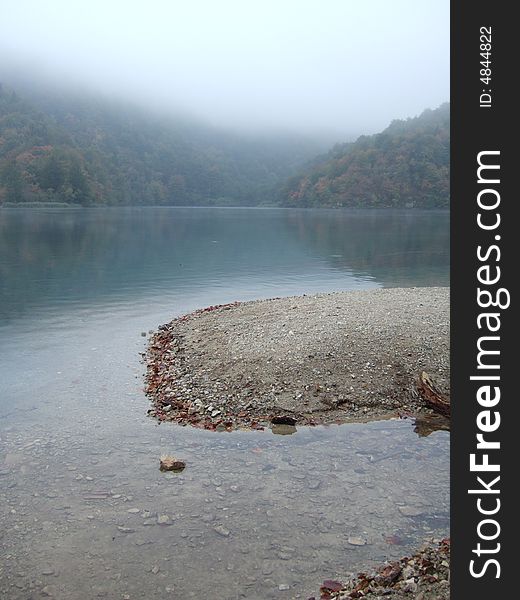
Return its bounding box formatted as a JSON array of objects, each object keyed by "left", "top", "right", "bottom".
[{"left": 0, "top": 0, "right": 449, "bottom": 135}]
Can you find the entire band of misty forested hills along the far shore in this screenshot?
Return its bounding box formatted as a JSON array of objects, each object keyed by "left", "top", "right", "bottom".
[{"left": 0, "top": 85, "right": 449, "bottom": 208}]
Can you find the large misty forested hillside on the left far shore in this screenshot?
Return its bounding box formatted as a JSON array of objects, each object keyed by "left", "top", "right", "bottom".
[{"left": 0, "top": 84, "right": 320, "bottom": 206}]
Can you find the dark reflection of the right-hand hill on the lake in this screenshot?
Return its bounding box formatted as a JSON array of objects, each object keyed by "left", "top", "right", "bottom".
[{"left": 287, "top": 210, "right": 449, "bottom": 287}]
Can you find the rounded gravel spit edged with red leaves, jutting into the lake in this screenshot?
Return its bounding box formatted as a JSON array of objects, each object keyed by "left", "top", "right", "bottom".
[{"left": 146, "top": 288, "right": 450, "bottom": 430}]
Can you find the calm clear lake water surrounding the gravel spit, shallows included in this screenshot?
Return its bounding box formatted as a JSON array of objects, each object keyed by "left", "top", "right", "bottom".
[{"left": 0, "top": 208, "right": 449, "bottom": 600}]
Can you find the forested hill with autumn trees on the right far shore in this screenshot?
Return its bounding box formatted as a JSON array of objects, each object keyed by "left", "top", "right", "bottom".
[{"left": 279, "top": 103, "right": 450, "bottom": 208}]
